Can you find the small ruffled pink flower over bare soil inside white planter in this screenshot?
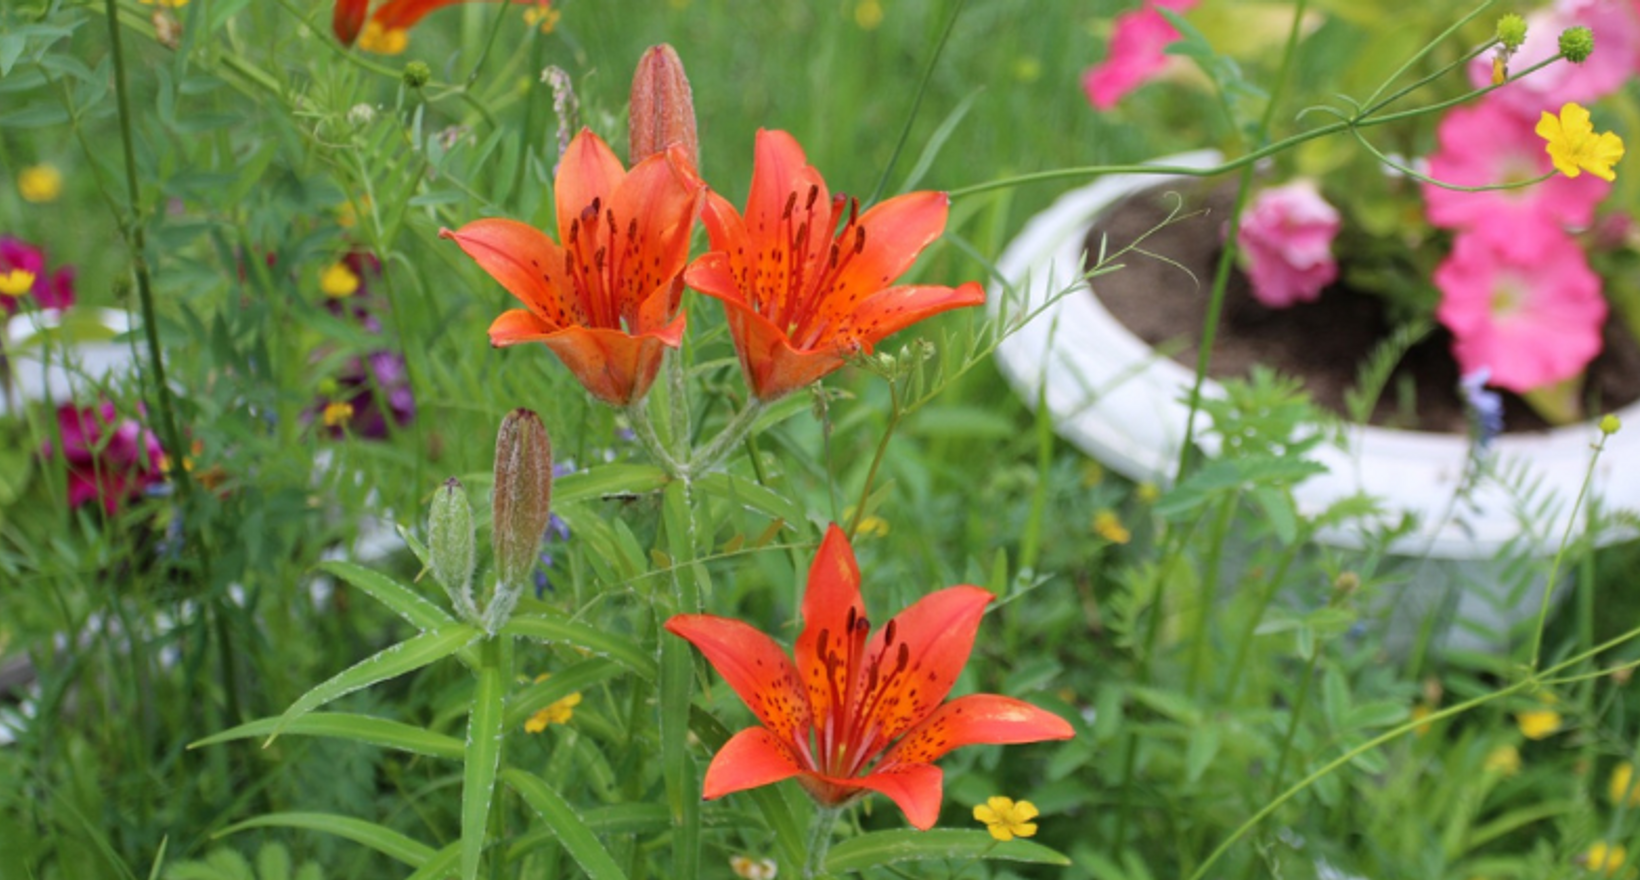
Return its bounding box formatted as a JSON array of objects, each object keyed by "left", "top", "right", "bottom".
[{"left": 1237, "top": 180, "right": 1340, "bottom": 308}]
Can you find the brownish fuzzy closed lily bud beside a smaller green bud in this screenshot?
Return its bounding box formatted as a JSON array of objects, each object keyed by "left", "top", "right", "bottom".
[{"left": 492, "top": 408, "right": 553, "bottom": 588}]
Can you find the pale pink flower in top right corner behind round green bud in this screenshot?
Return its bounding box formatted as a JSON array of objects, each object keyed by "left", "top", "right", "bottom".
[{"left": 1469, "top": 0, "right": 1640, "bottom": 121}]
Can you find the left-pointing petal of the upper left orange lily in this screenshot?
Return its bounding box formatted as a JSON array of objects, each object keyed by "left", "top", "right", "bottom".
[{"left": 438, "top": 218, "right": 589, "bottom": 326}]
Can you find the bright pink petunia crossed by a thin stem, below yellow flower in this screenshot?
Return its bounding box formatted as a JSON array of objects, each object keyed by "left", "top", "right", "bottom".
[{"left": 1424, "top": 93, "right": 1612, "bottom": 241}]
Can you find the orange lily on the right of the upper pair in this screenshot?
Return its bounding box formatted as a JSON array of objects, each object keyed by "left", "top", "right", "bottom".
[{"left": 684, "top": 129, "right": 986, "bottom": 401}]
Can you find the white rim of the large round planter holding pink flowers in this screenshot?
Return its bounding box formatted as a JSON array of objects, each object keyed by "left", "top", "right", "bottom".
[{"left": 987, "top": 151, "right": 1640, "bottom": 559}]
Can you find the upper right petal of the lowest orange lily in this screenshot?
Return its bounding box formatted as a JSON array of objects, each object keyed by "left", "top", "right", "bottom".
[{"left": 859, "top": 587, "right": 994, "bottom": 755}]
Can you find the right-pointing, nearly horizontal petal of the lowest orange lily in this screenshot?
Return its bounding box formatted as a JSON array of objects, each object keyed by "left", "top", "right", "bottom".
[{"left": 877, "top": 693, "right": 1076, "bottom": 767}]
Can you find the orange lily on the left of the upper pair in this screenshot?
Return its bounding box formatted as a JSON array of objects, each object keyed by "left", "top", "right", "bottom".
[{"left": 438, "top": 129, "right": 705, "bottom": 406}]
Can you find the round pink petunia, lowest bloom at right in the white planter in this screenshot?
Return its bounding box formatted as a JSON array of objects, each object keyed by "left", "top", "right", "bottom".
[{"left": 1435, "top": 225, "right": 1606, "bottom": 392}]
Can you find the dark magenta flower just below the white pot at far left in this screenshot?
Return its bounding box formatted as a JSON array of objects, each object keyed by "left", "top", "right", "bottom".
[{"left": 39, "top": 400, "right": 164, "bottom": 516}]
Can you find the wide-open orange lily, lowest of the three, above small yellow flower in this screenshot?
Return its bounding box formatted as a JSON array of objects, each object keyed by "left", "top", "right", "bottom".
[{"left": 666, "top": 526, "right": 1073, "bottom": 831}]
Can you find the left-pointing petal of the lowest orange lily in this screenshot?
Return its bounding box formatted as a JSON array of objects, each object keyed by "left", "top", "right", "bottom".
[{"left": 666, "top": 615, "right": 812, "bottom": 749}]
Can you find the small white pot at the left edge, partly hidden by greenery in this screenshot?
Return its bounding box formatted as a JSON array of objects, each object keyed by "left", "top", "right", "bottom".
[{"left": 0, "top": 306, "right": 133, "bottom": 413}]
